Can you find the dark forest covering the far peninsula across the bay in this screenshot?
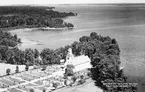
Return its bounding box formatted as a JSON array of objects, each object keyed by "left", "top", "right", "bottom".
[{"left": 0, "top": 6, "right": 76, "bottom": 29}]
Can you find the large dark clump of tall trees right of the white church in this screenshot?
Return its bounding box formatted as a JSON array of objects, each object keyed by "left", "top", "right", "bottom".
[{"left": 85, "top": 32, "right": 126, "bottom": 92}]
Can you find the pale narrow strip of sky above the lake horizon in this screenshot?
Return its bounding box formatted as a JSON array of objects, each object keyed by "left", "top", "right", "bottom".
[{"left": 0, "top": 0, "right": 145, "bottom": 5}]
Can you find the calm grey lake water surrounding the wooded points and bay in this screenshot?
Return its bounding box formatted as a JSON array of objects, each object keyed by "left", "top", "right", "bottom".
[{"left": 12, "top": 5, "right": 145, "bottom": 77}]
